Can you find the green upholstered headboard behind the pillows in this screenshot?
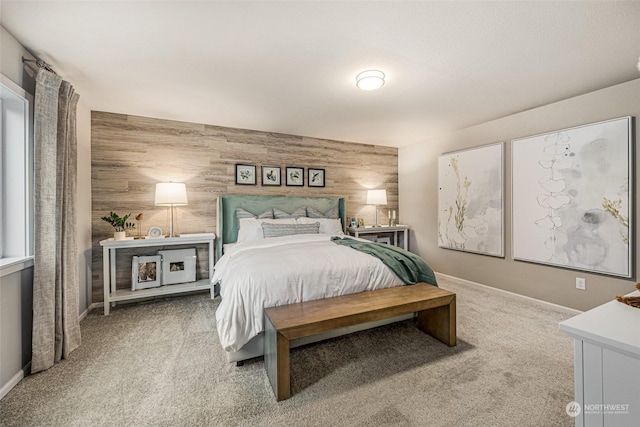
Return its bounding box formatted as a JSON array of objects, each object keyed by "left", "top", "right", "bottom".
[{"left": 216, "top": 195, "right": 347, "bottom": 258}]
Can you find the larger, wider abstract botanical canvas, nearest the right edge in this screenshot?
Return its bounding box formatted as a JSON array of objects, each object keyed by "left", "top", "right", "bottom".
[{"left": 511, "top": 117, "right": 633, "bottom": 277}]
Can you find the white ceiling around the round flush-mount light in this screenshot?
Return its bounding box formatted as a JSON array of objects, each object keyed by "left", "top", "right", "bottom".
[{"left": 0, "top": 0, "right": 640, "bottom": 146}]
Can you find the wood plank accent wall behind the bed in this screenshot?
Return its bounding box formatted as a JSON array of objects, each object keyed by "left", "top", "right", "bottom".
[{"left": 91, "top": 111, "right": 398, "bottom": 302}]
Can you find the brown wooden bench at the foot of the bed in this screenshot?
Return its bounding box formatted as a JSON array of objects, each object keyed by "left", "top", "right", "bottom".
[{"left": 264, "top": 283, "right": 456, "bottom": 401}]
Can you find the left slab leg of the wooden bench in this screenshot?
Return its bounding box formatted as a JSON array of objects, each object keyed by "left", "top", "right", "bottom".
[{"left": 264, "top": 314, "right": 291, "bottom": 402}]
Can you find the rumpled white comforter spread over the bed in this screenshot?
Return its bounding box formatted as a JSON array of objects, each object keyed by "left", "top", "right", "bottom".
[{"left": 212, "top": 234, "right": 404, "bottom": 351}]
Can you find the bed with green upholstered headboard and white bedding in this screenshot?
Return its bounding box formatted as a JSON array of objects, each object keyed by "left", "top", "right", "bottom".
[{"left": 212, "top": 195, "right": 435, "bottom": 362}]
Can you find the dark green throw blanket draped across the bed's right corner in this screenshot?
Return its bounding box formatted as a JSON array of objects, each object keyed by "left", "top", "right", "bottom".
[{"left": 331, "top": 237, "right": 438, "bottom": 286}]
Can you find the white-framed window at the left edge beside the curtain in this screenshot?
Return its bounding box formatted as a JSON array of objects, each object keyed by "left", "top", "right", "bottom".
[{"left": 0, "top": 74, "right": 33, "bottom": 275}]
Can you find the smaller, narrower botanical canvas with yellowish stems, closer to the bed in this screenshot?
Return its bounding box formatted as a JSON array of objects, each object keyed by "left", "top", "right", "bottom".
[{"left": 438, "top": 142, "right": 504, "bottom": 257}]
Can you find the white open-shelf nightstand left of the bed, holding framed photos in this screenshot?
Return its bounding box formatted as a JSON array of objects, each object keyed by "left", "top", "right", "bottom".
[{"left": 100, "top": 233, "right": 216, "bottom": 316}]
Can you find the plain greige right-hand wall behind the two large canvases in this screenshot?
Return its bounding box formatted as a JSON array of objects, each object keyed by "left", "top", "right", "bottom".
[{"left": 398, "top": 79, "right": 640, "bottom": 310}]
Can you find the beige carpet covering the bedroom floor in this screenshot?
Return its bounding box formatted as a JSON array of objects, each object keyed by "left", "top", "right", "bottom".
[{"left": 0, "top": 279, "right": 573, "bottom": 427}]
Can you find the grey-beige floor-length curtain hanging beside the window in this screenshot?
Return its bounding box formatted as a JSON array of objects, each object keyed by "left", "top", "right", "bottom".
[{"left": 31, "top": 68, "right": 80, "bottom": 373}]
